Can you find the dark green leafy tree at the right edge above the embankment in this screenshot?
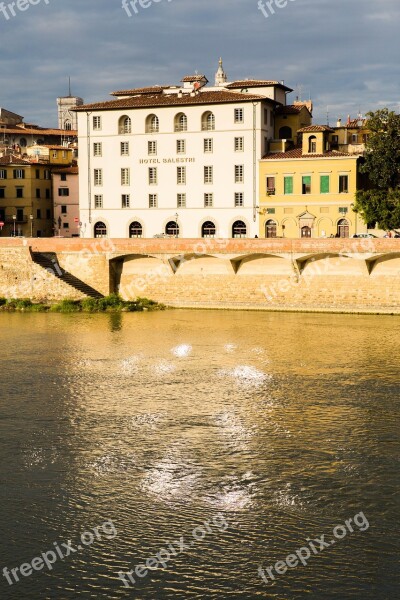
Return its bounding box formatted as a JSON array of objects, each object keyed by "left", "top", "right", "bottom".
[{"left": 355, "top": 108, "right": 400, "bottom": 231}]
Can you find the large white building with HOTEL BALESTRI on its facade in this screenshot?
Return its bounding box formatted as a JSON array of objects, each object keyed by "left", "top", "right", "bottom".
[{"left": 76, "top": 61, "right": 292, "bottom": 238}]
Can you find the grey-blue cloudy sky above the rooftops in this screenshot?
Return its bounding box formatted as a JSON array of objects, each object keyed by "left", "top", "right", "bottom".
[{"left": 0, "top": 0, "right": 400, "bottom": 127}]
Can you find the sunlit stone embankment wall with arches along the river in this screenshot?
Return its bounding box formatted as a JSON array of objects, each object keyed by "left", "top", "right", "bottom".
[{"left": 0, "top": 238, "right": 400, "bottom": 314}]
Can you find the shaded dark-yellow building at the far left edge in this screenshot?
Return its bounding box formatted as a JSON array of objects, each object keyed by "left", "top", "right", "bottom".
[{"left": 0, "top": 154, "right": 54, "bottom": 237}]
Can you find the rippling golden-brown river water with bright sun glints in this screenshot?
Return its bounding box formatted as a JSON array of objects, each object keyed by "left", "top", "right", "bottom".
[{"left": 0, "top": 310, "right": 400, "bottom": 600}]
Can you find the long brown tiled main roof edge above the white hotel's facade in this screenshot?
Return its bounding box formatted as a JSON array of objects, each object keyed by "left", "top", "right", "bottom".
[{"left": 72, "top": 90, "right": 275, "bottom": 112}]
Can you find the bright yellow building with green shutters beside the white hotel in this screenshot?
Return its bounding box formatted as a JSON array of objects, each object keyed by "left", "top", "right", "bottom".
[{"left": 258, "top": 125, "right": 367, "bottom": 238}]
